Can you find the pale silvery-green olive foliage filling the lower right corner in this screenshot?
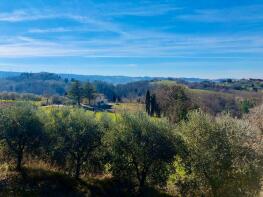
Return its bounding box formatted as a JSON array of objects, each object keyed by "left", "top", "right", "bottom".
[{"left": 175, "top": 111, "right": 262, "bottom": 196}]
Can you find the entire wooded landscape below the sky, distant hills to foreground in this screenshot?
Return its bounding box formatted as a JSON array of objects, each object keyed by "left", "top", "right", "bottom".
[{"left": 0, "top": 73, "right": 263, "bottom": 197}]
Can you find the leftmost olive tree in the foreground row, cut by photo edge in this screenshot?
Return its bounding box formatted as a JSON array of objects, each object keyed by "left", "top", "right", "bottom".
[{"left": 0, "top": 103, "right": 42, "bottom": 171}]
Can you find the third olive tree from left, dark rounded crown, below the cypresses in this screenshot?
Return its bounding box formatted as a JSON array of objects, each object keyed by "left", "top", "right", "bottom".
[{"left": 111, "top": 113, "right": 182, "bottom": 194}]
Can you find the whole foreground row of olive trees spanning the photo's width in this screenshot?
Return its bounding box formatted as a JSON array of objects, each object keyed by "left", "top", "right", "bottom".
[{"left": 0, "top": 104, "right": 263, "bottom": 197}]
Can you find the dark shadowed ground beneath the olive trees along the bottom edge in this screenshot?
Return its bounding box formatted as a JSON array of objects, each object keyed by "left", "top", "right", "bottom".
[{"left": 0, "top": 168, "right": 171, "bottom": 197}]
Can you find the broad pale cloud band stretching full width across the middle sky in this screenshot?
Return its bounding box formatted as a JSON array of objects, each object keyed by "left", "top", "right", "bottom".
[{"left": 0, "top": 32, "right": 263, "bottom": 59}]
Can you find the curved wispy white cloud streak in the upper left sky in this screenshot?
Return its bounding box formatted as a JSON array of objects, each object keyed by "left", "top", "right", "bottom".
[{"left": 0, "top": 9, "right": 125, "bottom": 34}]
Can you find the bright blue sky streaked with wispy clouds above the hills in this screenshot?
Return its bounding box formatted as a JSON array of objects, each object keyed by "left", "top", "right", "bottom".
[{"left": 0, "top": 0, "right": 263, "bottom": 79}]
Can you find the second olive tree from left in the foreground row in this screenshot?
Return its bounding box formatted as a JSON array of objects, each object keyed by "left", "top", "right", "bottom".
[{"left": 43, "top": 108, "right": 103, "bottom": 178}]
